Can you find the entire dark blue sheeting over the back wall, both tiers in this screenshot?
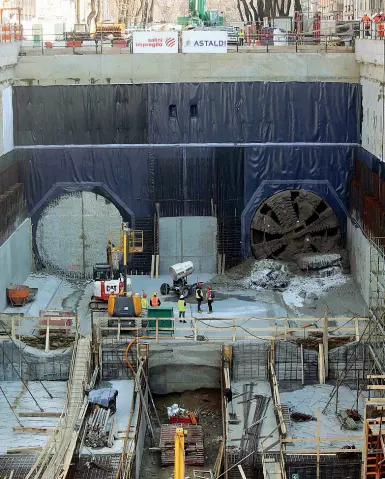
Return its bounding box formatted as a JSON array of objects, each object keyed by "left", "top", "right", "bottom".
[{"left": 13, "top": 82, "right": 361, "bottom": 261}]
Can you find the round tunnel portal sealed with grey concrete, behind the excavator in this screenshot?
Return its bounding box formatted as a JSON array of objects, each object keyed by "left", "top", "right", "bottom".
[{"left": 36, "top": 191, "right": 122, "bottom": 275}]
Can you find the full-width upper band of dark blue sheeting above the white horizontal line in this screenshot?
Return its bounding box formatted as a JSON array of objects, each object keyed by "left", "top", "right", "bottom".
[{"left": 13, "top": 82, "right": 361, "bottom": 146}]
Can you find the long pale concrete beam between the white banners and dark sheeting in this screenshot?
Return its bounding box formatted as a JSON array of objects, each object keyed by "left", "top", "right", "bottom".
[{"left": 13, "top": 53, "right": 359, "bottom": 85}]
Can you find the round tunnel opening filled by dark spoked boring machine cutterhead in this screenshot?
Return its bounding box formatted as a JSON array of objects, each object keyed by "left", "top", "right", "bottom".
[{"left": 251, "top": 190, "right": 341, "bottom": 261}]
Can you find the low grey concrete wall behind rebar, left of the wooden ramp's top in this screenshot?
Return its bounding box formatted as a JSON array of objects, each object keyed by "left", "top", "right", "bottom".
[{"left": 0, "top": 340, "right": 72, "bottom": 381}]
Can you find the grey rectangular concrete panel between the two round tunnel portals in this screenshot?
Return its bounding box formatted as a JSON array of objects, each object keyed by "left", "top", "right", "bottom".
[{"left": 159, "top": 216, "right": 217, "bottom": 274}]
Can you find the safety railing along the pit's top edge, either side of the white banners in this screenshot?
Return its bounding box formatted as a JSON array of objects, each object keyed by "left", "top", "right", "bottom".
[{"left": 10, "top": 28, "right": 354, "bottom": 56}]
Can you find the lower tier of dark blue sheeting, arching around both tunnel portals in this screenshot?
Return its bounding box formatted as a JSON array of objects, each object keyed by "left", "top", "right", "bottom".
[{"left": 16, "top": 145, "right": 355, "bottom": 256}]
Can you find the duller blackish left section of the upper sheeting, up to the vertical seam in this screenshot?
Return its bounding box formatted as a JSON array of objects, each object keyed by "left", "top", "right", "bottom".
[{"left": 13, "top": 85, "right": 148, "bottom": 146}]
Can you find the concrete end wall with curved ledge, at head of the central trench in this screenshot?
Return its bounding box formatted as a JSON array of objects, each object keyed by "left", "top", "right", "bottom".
[{"left": 149, "top": 342, "right": 222, "bottom": 394}]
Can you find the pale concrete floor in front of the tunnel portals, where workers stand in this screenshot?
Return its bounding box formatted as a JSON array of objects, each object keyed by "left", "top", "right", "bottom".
[{"left": 6, "top": 273, "right": 365, "bottom": 341}]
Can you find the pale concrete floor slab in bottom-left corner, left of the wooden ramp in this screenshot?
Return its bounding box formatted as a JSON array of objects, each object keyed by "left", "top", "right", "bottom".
[{"left": 0, "top": 381, "right": 67, "bottom": 454}]
